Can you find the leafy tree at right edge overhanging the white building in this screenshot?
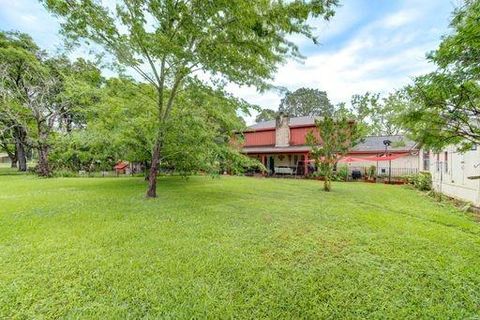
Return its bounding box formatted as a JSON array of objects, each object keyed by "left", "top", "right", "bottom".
[{"left": 401, "top": 0, "right": 480, "bottom": 149}]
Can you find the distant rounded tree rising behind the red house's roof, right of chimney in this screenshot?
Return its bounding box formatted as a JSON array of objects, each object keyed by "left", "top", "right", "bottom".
[{"left": 278, "top": 88, "right": 335, "bottom": 117}]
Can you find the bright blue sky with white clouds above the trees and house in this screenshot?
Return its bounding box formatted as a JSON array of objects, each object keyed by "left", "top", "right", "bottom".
[{"left": 0, "top": 0, "right": 459, "bottom": 122}]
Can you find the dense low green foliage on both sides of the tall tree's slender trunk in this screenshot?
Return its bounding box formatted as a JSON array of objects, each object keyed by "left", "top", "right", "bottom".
[{"left": 51, "top": 78, "right": 252, "bottom": 176}]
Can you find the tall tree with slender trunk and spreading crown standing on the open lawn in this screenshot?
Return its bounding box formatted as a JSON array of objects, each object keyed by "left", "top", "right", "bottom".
[{"left": 42, "top": 0, "right": 336, "bottom": 197}]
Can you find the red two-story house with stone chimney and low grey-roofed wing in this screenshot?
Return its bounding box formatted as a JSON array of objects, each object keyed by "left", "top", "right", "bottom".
[{"left": 242, "top": 114, "right": 419, "bottom": 176}]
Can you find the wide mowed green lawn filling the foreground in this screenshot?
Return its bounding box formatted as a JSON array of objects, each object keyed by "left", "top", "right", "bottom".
[{"left": 0, "top": 175, "right": 480, "bottom": 319}]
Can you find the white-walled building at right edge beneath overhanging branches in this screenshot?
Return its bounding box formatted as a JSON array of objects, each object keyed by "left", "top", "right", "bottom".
[{"left": 428, "top": 146, "right": 480, "bottom": 207}]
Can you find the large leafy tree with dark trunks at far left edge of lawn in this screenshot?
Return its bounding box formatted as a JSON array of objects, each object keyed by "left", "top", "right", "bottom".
[{"left": 0, "top": 32, "right": 101, "bottom": 177}]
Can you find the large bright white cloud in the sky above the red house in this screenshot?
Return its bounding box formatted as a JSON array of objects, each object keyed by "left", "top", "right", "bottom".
[{"left": 231, "top": 0, "right": 451, "bottom": 123}]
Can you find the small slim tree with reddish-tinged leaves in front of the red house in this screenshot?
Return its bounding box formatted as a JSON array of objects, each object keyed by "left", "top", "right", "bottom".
[{"left": 307, "top": 117, "right": 362, "bottom": 191}]
